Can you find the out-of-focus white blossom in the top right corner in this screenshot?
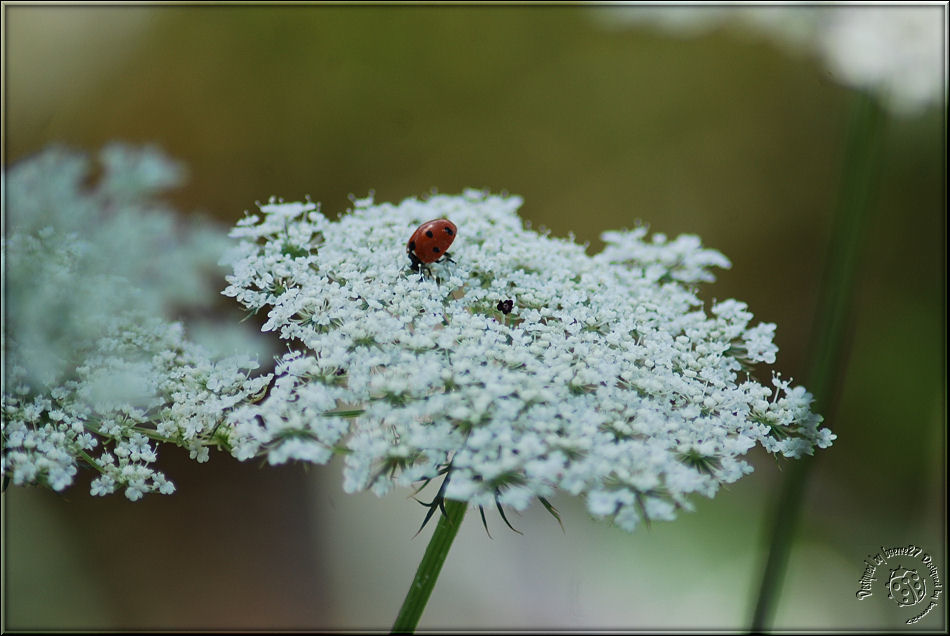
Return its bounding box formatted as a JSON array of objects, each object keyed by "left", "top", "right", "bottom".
[{"left": 596, "top": 3, "right": 947, "bottom": 114}]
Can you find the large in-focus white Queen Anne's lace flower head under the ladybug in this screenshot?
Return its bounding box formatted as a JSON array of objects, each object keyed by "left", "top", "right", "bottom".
[{"left": 222, "top": 191, "right": 834, "bottom": 530}]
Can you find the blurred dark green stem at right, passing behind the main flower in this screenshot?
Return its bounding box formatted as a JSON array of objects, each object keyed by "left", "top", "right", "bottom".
[{"left": 752, "top": 93, "right": 886, "bottom": 632}]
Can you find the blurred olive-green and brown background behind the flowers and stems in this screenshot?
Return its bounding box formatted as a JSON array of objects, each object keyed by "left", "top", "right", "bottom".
[{"left": 3, "top": 6, "right": 947, "bottom": 630}]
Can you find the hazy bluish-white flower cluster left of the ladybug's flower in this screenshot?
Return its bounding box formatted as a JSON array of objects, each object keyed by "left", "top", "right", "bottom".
[{"left": 2, "top": 144, "right": 267, "bottom": 500}]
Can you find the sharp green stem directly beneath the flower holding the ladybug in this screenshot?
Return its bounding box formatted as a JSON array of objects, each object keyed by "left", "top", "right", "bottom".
[{"left": 393, "top": 499, "right": 468, "bottom": 634}]
